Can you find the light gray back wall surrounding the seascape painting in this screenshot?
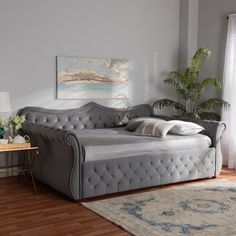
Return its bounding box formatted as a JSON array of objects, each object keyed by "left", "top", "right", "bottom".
[{"left": 0, "top": 0, "right": 180, "bottom": 110}]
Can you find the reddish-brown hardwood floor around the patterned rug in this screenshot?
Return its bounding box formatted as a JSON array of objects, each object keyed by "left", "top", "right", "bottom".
[{"left": 0, "top": 168, "right": 236, "bottom": 236}]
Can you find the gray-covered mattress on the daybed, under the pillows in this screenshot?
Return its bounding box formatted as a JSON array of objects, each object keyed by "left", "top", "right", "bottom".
[{"left": 76, "top": 128, "right": 211, "bottom": 161}]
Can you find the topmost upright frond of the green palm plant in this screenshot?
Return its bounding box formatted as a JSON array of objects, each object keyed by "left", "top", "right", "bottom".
[{"left": 187, "top": 48, "right": 211, "bottom": 73}]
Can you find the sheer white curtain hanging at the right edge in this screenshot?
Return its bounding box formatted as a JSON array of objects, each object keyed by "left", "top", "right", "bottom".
[{"left": 222, "top": 14, "right": 236, "bottom": 169}]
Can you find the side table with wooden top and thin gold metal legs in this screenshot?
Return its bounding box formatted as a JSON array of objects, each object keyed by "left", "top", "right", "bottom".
[{"left": 0, "top": 147, "right": 39, "bottom": 193}]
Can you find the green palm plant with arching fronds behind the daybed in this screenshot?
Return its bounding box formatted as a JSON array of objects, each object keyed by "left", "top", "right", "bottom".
[{"left": 153, "top": 48, "right": 230, "bottom": 120}]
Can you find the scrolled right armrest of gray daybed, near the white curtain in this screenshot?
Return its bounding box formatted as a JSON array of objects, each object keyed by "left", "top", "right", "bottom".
[{"left": 155, "top": 115, "right": 226, "bottom": 176}]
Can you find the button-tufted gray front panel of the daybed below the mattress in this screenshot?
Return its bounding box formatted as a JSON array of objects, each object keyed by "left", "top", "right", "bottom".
[{"left": 82, "top": 148, "right": 215, "bottom": 197}]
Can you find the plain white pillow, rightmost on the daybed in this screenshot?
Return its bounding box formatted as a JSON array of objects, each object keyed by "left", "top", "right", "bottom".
[{"left": 169, "top": 120, "right": 204, "bottom": 135}]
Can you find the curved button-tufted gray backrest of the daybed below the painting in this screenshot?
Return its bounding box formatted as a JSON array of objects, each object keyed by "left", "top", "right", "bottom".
[{"left": 19, "top": 102, "right": 153, "bottom": 130}]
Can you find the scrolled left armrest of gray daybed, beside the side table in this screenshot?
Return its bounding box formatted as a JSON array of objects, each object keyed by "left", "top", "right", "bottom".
[{"left": 23, "top": 122, "right": 82, "bottom": 200}]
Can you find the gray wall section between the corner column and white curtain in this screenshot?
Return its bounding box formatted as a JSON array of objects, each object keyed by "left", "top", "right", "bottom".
[{"left": 198, "top": 0, "right": 236, "bottom": 97}]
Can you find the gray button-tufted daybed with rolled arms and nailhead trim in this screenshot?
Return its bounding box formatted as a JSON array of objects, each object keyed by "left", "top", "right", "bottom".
[{"left": 19, "top": 103, "right": 225, "bottom": 201}]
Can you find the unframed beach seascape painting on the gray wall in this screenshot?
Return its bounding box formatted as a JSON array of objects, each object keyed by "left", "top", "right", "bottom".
[{"left": 57, "top": 57, "right": 128, "bottom": 99}]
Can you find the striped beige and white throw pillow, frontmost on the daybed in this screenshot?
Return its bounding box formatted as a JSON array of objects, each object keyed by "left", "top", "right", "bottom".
[{"left": 134, "top": 119, "right": 174, "bottom": 137}]
